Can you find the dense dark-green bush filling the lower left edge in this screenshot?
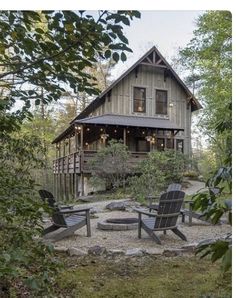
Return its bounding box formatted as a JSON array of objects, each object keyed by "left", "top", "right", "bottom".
[{"left": 0, "top": 134, "right": 58, "bottom": 294}]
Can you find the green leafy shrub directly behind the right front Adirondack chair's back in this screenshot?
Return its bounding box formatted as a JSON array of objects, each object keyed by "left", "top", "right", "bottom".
[{"left": 129, "top": 150, "right": 187, "bottom": 200}]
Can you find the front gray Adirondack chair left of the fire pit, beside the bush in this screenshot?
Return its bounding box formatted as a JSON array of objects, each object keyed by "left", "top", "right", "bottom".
[{"left": 43, "top": 207, "right": 91, "bottom": 241}]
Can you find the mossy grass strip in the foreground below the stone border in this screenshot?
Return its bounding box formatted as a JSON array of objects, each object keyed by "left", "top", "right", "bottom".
[{"left": 56, "top": 256, "right": 231, "bottom": 298}]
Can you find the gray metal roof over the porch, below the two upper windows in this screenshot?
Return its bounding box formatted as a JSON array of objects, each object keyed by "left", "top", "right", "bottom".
[{"left": 74, "top": 114, "right": 184, "bottom": 130}]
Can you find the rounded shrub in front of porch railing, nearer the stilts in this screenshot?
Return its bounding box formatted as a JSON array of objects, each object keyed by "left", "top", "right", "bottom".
[{"left": 90, "top": 140, "right": 130, "bottom": 188}]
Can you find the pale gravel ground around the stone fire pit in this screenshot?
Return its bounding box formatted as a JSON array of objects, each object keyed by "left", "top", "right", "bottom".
[{"left": 47, "top": 181, "right": 231, "bottom": 253}]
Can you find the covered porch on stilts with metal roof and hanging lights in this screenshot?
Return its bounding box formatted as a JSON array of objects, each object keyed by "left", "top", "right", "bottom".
[{"left": 53, "top": 115, "right": 184, "bottom": 198}]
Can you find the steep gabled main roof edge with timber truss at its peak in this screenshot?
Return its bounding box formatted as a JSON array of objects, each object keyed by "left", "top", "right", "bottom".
[{"left": 70, "top": 46, "right": 202, "bottom": 123}]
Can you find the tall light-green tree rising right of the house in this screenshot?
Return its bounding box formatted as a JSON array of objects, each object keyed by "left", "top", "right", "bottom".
[{"left": 180, "top": 11, "right": 232, "bottom": 166}]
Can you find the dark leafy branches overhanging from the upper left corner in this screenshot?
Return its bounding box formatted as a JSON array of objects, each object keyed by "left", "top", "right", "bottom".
[{"left": 0, "top": 10, "right": 140, "bottom": 126}]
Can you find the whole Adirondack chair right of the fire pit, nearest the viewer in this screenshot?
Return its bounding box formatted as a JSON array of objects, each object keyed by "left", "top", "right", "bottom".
[{"left": 135, "top": 191, "right": 187, "bottom": 244}]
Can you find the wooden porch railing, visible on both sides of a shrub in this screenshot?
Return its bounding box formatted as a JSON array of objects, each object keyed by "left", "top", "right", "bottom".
[{"left": 53, "top": 150, "right": 147, "bottom": 174}]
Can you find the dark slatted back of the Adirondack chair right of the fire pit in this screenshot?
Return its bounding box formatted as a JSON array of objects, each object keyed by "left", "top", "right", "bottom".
[{"left": 154, "top": 190, "right": 185, "bottom": 228}]
